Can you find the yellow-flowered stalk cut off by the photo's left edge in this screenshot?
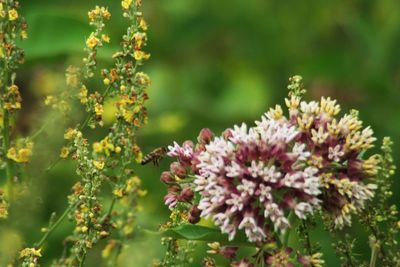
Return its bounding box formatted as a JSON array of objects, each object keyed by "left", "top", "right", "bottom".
[{"left": 0, "top": 0, "right": 28, "bottom": 207}]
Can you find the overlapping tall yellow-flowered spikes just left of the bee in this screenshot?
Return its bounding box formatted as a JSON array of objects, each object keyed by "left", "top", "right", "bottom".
[{"left": 21, "top": 0, "right": 150, "bottom": 266}]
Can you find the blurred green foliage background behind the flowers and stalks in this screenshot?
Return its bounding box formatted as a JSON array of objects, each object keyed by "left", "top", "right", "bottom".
[{"left": 0, "top": 0, "right": 400, "bottom": 266}]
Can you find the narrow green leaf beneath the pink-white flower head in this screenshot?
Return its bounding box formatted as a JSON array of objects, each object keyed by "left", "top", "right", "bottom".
[{"left": 143, "top": 224, "right": 255, "bottom": 247}]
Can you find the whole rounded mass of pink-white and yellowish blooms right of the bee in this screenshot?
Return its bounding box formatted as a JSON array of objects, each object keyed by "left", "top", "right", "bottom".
[{"left": 162, "top": 96, "right": 379, "bottom": 242}]
